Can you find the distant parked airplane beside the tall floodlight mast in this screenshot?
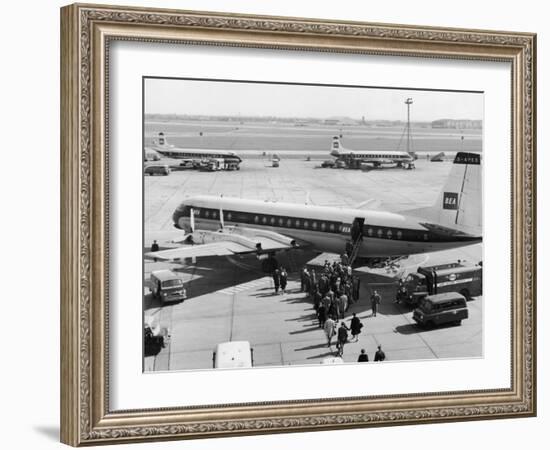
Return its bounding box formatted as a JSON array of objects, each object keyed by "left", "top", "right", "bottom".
[{"left": 330, "top": 136, "right": 416, "bottom": 169}]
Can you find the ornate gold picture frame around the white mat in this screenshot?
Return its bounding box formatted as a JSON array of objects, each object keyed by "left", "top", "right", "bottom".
[{"left": 61, "top": 4, "right": 536, "bottom": 446}]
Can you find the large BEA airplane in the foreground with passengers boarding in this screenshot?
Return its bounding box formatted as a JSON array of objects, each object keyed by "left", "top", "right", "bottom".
[{"left": 145, "top": 152, "right": 482, "bottom": 269}]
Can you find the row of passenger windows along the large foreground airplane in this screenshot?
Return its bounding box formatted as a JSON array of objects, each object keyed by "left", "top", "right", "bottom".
[{"left": 195, "top": 209, "right": 428, "bottom": 241}]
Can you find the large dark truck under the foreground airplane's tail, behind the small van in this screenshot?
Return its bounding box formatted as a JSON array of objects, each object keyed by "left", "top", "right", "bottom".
[{"left": 397, "top": 262, "right": 483, "bottom": 305}]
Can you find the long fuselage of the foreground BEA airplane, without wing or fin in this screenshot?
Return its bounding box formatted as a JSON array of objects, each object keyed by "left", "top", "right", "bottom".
[{"left": 173, "top": 196, "right": 481, "bottom": 258}]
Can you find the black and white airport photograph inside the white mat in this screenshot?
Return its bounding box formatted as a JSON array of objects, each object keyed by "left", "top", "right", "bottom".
[{"left": 143, "top": 77, "right": 484, "bottom": 372}]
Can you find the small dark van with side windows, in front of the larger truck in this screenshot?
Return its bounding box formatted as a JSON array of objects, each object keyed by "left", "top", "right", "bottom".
[{"left": 413, "top": 292, "right": 468, "bottom": 327}]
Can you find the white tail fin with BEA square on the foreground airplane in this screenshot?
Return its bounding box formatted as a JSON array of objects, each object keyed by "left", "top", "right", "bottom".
[{"left": 422, "top": 152, "right": 482, "bottom": 235}]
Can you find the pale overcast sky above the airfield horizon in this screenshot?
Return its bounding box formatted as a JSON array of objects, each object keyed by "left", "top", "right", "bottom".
[{"left": 145, "top": 79, "right": 483, "bottom": 121}]
